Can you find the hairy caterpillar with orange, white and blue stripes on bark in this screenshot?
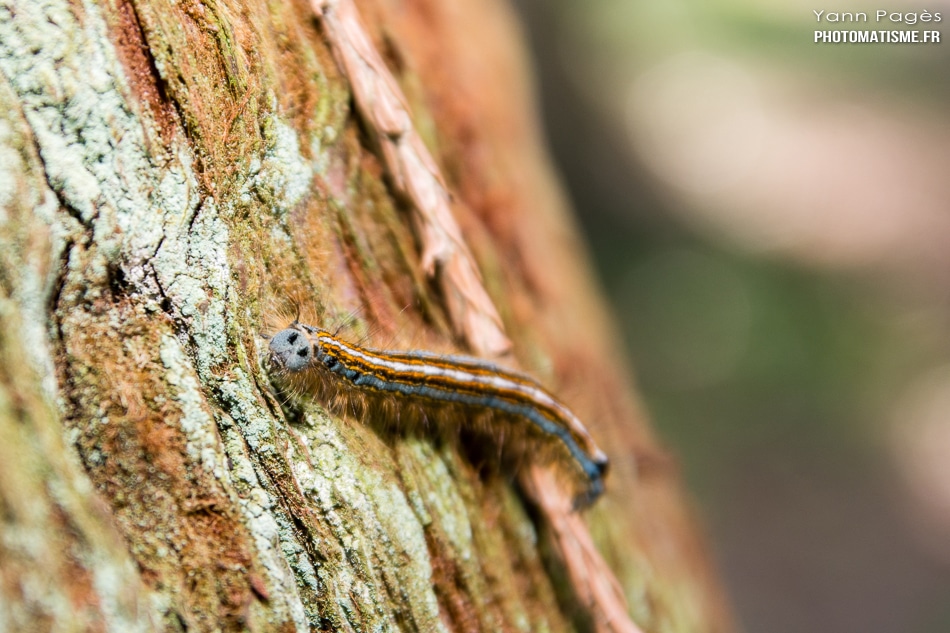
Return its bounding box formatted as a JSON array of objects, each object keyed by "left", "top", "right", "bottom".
[{"left": 269, "top": 321, "right": 607, "bottom": 508}]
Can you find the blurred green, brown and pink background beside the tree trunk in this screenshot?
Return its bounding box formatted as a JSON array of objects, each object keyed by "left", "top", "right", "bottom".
[{"left": 516, "top": 0, "right": 950, "bottom": 633}]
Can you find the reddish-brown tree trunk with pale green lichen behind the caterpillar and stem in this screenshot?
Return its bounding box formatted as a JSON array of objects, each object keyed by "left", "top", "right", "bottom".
[{"left": 0, "top": 0, "right": 730, "bottom": 631}]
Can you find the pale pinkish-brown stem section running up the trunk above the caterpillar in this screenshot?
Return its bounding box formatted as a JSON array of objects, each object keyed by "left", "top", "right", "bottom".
[{"left": 311, "top": 0, "right": 511, "bottom": 358}]
